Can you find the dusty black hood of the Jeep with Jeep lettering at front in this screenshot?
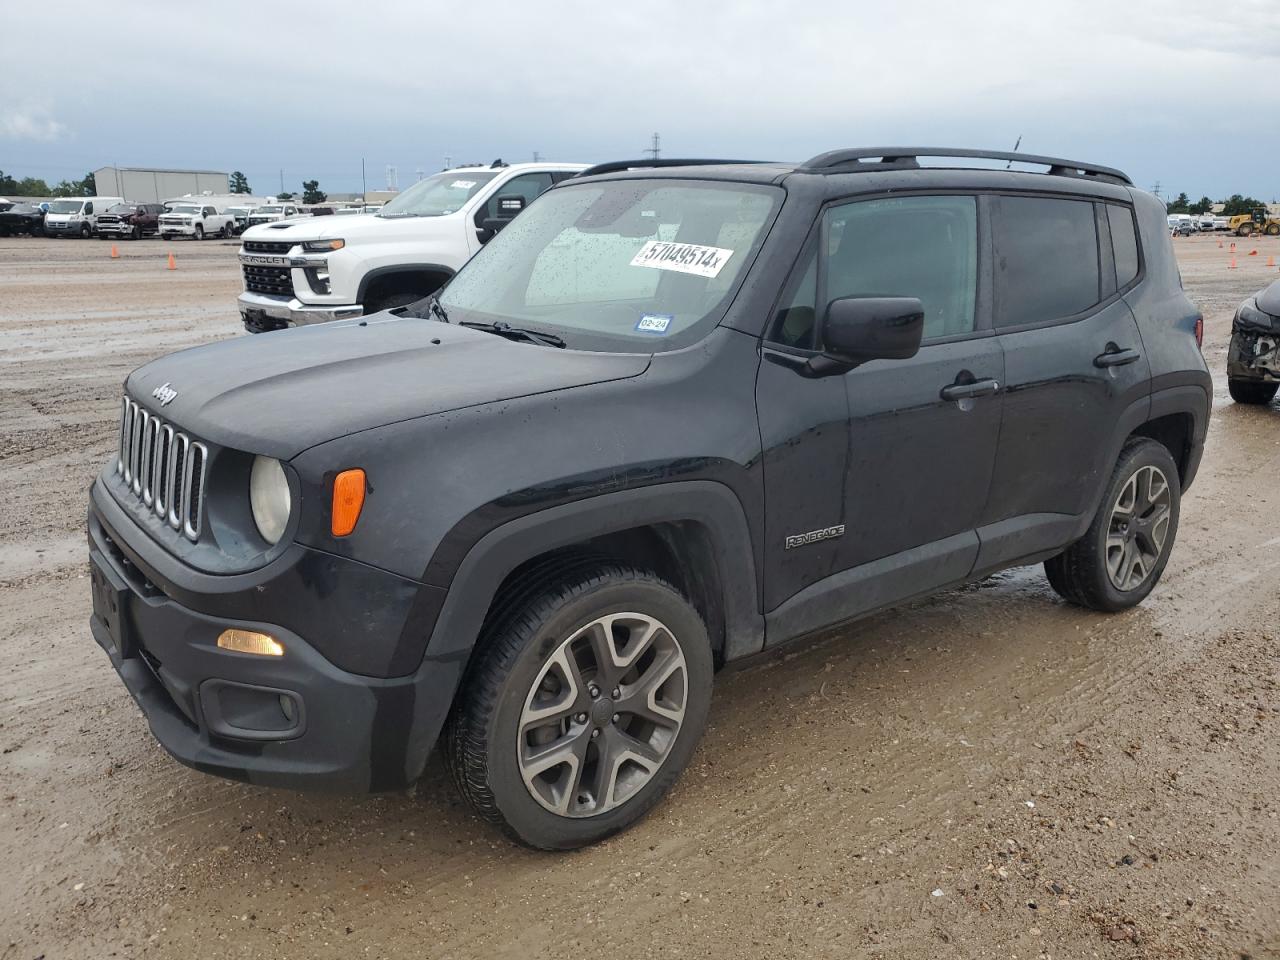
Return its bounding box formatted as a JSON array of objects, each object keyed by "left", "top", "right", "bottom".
[{"left": 125, "top": 314, "right": 649, "bottom": 460}]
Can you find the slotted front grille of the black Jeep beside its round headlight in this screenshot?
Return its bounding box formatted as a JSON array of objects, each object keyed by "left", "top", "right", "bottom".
[{"left": 115, "top": 397, "right": 209, "bottom": 540}]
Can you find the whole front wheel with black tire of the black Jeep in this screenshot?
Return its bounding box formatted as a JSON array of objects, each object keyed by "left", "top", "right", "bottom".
[{"left": 445, "top": 561, "right": 712, "bottom": 850}]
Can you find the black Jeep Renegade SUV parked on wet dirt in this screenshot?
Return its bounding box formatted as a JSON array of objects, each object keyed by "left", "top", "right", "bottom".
[{"left": 88, "top": 148, "right": 1210, "bottom": 849}]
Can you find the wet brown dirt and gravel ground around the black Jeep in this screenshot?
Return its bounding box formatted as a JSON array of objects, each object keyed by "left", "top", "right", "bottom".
[{"left": 0, "top": 238, "right": 1280, "bottom": 960}]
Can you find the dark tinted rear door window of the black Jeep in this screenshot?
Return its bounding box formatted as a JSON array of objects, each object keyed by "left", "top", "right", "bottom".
[{"left": 991, "top": 197, "right": 1101, "bottom": 328}]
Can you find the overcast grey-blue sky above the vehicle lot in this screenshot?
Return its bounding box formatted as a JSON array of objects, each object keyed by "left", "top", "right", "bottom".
[{"left": 0, "top": 0, "right": 1280, "bottom": 200}]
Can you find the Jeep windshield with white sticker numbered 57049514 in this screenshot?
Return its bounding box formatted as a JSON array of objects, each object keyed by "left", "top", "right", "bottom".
[{"left": 440, "top": 180, "right": 782, "bottom": 352}]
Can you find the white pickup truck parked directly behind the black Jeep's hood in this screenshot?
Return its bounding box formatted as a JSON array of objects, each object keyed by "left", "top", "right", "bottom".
[{"left": 239, "top": 160, "right": 588, "bottom": 333}]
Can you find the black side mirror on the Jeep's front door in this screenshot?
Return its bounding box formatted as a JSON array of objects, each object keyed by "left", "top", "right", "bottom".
[{"left": 809, "top": 297, "right": 924, "bottom": 376}]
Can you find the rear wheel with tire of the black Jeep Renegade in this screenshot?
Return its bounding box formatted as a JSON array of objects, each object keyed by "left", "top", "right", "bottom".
[{"left": 1044, "top": 436, "right": 1181, "bottom": 612}]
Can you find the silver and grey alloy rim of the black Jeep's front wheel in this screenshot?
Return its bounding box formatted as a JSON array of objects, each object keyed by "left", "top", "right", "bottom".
[{"left": 516, "top": 613, "right": 689, "bottom": 818}]
